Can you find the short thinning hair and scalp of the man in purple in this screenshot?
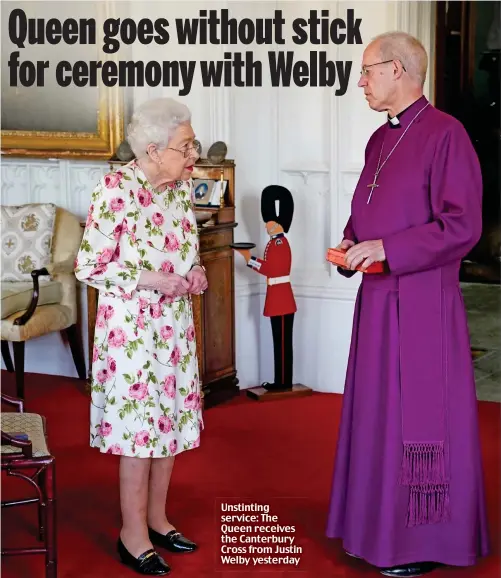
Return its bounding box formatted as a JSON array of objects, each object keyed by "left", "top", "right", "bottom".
[{"left": 372, "top": 32, "right": 428, "bottom": 86}]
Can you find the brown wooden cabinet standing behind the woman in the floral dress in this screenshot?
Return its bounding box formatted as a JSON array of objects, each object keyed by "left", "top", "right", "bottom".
[{"left": 87, "top": 161, "right": 239, "bottom": 408}]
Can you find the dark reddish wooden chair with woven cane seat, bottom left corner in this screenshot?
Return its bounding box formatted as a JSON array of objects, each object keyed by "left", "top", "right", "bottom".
[{"left": 1, "top": 393, "right": 57, "bottom": 578}]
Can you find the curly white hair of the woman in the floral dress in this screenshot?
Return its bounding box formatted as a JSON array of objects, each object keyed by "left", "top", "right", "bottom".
[{"left": 127, "top": 98, "right": 191, "bottom": 158}]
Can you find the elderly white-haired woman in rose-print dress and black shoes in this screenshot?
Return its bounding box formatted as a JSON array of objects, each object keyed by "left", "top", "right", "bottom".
[{"left": 75, "top": 98, "right": 207, "bottom": 576}]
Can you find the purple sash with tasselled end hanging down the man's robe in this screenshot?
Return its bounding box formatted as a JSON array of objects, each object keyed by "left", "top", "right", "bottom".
[{"left": 399, "top": 269, "right": 457, "bottom": 527}]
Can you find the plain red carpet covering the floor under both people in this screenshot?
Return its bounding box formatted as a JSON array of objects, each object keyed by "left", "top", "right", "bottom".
[{"left": 2, "top": 372, "right": 500, "bottom": 578}]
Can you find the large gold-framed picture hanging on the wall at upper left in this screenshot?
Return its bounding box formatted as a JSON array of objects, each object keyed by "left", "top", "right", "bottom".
[{"left": 1, "top": 1, "right": 127, "bottom": 160}]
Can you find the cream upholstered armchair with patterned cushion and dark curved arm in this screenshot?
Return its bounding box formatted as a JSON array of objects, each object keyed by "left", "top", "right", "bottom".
[{"left": 1, "top": 204, "right": 86, "bottom": 399}]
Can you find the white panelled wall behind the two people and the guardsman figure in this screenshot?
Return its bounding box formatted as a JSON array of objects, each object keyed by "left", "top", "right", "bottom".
[{"left": 1, "top": 2, "right": 433, "bottom": 392}]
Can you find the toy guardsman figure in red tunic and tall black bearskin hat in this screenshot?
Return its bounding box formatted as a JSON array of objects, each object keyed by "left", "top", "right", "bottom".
[{"left": 232, "top": 185, "right": 297, "bottom": 391}]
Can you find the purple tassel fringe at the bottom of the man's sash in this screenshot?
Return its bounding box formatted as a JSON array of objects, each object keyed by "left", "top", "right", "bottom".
[{"left": 400, "top": 442, "right": 450, "bottom": 527}]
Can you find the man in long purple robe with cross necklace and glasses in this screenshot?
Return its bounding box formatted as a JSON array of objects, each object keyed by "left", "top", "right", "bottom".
[{"left": 327, "top": 33, "right": 489, "bottom": 577}]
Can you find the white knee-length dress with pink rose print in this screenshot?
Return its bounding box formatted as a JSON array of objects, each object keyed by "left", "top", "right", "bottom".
[{"left": 75, "top": 161, "right": 204, "bottom": 458}]
